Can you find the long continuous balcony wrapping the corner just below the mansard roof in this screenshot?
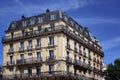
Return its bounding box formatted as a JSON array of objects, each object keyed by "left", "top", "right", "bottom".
[{"left": 2, "top": 25, "right": 104, "bottom": 56}]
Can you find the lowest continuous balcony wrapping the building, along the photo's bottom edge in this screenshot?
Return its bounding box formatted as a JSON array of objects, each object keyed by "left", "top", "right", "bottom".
[{"left": 3, "top": 71, "right": 91, "bottom": 80}]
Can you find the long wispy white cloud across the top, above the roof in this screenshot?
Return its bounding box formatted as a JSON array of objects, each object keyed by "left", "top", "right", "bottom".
[{"left": 0, "top": 0, "right": 101, "bottom": 16}]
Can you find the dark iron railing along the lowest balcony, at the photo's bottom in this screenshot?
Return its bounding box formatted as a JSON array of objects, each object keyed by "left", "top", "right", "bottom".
[{"left": 3, "top": 71, "right": 90, "bottom": 80}]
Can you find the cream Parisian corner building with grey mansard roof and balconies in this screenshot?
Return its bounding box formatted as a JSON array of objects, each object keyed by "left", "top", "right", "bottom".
[{"left": 2, "top": 10, "right": 104, "bottom": 80}]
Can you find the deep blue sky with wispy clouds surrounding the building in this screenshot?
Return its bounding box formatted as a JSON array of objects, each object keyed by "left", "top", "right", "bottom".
[{"left": 0, "top": 0, "right": 120, "bottom": 64}]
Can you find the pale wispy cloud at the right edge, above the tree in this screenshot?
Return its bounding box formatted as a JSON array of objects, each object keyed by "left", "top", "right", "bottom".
[{"left": 101, "top": 37, "right": 120, "bottom": 50}]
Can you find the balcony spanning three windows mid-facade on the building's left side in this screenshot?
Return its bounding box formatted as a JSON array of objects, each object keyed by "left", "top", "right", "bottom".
[{"left": 16, "top": 57, "right": 42, "bottom": 65}]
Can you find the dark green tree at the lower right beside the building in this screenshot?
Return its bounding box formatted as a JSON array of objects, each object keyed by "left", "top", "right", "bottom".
[{"left": 104, "top": 59, "right": 120, "bottom": 80}]
